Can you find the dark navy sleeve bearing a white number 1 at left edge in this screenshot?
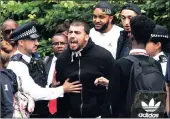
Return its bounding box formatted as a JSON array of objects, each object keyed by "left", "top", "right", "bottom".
[{"left": 0, "top": 73, "right": 13, "bottom": 118}]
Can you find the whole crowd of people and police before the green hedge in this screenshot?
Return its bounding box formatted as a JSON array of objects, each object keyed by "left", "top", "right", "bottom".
[{"left": 0, "top": 1, "right": 170, "bottom": 118}]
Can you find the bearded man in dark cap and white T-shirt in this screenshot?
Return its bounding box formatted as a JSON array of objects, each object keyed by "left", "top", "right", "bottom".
[{"left": 90, "top": 1, "right": 123, "bottom": 58}]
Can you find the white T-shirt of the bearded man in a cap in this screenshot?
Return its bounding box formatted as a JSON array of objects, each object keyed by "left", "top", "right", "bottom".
[{"left": 89, "top": 25, "right": 123, "bottom": 58}]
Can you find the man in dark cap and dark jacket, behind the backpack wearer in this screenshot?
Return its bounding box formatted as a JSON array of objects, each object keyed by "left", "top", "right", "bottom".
[{"left": 116, "top": 3, "right": 141, "bottom": 59}]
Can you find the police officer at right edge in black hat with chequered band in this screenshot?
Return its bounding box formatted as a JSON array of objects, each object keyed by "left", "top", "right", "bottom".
[{"left": 146, "top": 25, "right": 170, "bottom": 76}]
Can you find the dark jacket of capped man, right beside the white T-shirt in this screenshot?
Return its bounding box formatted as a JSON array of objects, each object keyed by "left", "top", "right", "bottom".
[{"left": 116, "top": 30, "right": 132, "bottom": 60}]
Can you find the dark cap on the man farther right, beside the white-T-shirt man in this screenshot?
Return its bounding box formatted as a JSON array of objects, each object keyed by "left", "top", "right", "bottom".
[{"left": 120, "top": 3, "right": 141, "bottom": 15}]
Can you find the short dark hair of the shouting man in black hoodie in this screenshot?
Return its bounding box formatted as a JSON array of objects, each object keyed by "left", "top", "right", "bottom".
[{"left": 70, "top": 21, "right": 90, "bottom": 34}]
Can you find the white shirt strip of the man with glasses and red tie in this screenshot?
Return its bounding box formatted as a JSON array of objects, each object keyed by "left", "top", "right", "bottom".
[{"left": 46, "top": 56, "right": 57, "bottom": 87}]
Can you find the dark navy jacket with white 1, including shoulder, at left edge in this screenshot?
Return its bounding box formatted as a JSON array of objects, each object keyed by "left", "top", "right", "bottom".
[{"left": 0, "top": 69, "right": 18, "bottom": 118}]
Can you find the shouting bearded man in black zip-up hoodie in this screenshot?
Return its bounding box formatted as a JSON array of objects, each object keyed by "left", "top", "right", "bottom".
[{"left": 56, "top": 21, "right": 114, "bottom": 118}]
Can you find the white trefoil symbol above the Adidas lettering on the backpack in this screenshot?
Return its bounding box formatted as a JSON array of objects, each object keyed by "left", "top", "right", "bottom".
[{"left": 141, "top": 98, "right": 161, "bottom": 112}]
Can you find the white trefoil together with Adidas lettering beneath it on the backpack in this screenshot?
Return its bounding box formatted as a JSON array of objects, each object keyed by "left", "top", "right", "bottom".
[{"left": 138, "top": 98, "right": 161, "bottom": 118}]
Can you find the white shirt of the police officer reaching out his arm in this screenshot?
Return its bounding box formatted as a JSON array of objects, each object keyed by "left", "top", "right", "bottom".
[{"left": 7, "top": 51, "right": 64, "bottom": 101}]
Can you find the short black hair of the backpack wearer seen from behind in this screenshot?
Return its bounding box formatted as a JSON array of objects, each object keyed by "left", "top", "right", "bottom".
[{"left": 130, "top": 15, "right": 155, "bottom": 45}]
